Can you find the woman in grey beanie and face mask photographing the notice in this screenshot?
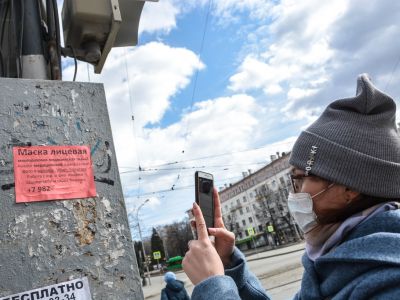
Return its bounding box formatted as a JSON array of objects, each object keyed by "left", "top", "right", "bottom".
[{"left": 183, "top": 74, "right": 400, "bottom": 299}]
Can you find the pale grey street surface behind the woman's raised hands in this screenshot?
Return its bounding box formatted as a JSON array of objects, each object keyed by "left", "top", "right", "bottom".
[{"left": 143, "top": 244, "right": 304, "bottom": 300}]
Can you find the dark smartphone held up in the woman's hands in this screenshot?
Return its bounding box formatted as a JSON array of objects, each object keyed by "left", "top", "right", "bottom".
[{"left": 194, "top": 171, "right": 214, "bottom": 228}]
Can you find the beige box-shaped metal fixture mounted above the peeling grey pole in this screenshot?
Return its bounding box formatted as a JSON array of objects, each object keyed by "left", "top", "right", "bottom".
[{"left": 62, "top": 0, "right": 154, "bottom": 73}]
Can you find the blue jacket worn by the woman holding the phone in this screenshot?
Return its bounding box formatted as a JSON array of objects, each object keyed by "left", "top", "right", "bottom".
[{"left": 192, "top": 209, "right": 400, "bottom": 300}]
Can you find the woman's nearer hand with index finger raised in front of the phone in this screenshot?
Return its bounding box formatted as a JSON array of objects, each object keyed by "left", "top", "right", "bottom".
[{"left": 182, "top": 203, "right": 224, "bottom": 285}]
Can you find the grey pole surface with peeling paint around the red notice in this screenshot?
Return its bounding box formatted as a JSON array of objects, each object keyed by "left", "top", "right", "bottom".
[{"left": 0, "top": 78, "right": 143, "bottom": 300}]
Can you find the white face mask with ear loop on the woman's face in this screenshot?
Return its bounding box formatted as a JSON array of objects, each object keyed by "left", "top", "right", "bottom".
[{"left": 288, "top": 183, "right": 334, "bottom": 233}]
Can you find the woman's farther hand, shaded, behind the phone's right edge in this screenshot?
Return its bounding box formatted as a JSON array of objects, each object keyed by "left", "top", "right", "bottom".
[{"left": 208, "top": 188, "right": 235, "bottom": 267}]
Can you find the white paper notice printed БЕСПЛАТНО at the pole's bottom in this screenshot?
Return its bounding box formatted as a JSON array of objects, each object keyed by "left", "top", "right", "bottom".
[{"left": 0, "top": 277, "right": 92, "bottom": 300}]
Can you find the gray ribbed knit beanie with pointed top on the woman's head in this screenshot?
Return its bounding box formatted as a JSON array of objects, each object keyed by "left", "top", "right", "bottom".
[{"left": 289, "top": 74, "right": 400, "bottom": 198}]
